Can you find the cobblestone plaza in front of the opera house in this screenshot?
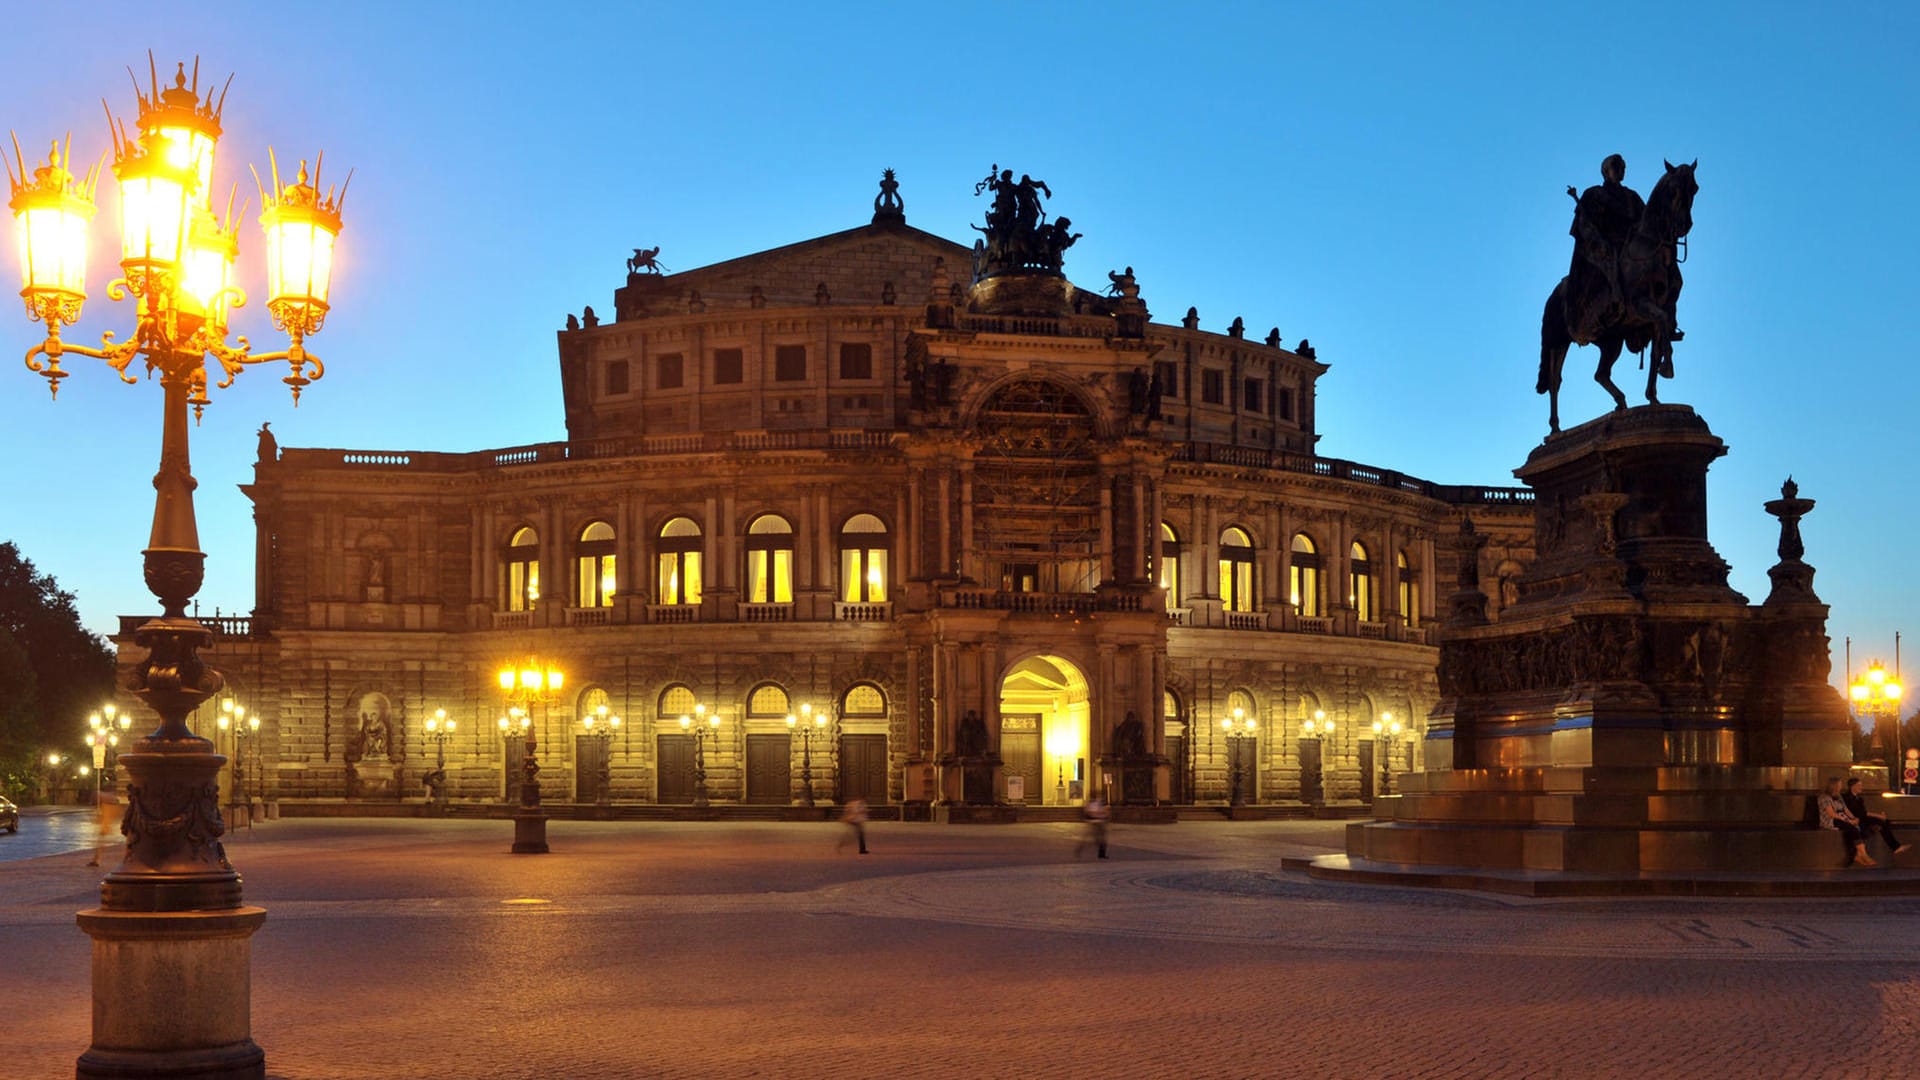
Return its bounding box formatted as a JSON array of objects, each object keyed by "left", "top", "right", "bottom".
[{"left": 0, "top": 821, "right": 1920, "bottom": 1080}]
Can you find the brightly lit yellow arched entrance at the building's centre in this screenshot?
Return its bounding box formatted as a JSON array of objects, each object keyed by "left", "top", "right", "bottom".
[{"left": 1000, "top": 655, "right": 1092, "bottom": 807}]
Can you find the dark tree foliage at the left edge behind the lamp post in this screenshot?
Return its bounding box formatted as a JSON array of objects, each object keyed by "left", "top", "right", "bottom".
[{"left": 0, "top": 542, "right": 113, "bottom": 792}]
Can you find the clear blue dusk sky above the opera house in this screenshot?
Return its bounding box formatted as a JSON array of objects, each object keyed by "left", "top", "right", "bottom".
[{"left": 0, "top": 2, "right": 1920, "bottom": 707}]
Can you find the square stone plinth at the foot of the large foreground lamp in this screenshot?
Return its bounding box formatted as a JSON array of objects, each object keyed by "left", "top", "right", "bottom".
[{"left": 75, "top": 907, "right": 267, "bottom": 1080}]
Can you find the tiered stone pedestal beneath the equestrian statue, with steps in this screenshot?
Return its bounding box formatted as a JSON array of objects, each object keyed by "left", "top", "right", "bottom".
[{"left": 1348, "top": 405, "right": 1851, "bottom": 876}]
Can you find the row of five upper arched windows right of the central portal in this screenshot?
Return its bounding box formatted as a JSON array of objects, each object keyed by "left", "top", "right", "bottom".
[{"left": 1160, "top": 521, "right": 1421, "bottom": 626}]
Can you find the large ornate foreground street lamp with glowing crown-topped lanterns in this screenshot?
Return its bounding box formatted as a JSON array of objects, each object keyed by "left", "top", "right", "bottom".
[{"left": 8, "top": 63, "right": 346, "bottom": 1078}]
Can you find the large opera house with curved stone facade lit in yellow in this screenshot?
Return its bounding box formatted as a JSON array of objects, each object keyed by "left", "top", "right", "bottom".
[{"left": 123, "top": 171, "right": 1532, "bottom": 805}]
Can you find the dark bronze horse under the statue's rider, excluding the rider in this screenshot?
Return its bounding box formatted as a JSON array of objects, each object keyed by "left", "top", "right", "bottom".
[{"left": 1534, "top": 160, "right": 1699, "bottom": 430}]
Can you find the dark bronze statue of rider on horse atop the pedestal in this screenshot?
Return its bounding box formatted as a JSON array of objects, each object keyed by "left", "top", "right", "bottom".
[{"left": 1534, "top": 154, "right": 1699, "bottom": 430}]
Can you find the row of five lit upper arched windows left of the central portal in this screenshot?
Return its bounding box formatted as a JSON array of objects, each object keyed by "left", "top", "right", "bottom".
[{"left": 501, "top": 513, "right": 889, "bottom": 611}]
